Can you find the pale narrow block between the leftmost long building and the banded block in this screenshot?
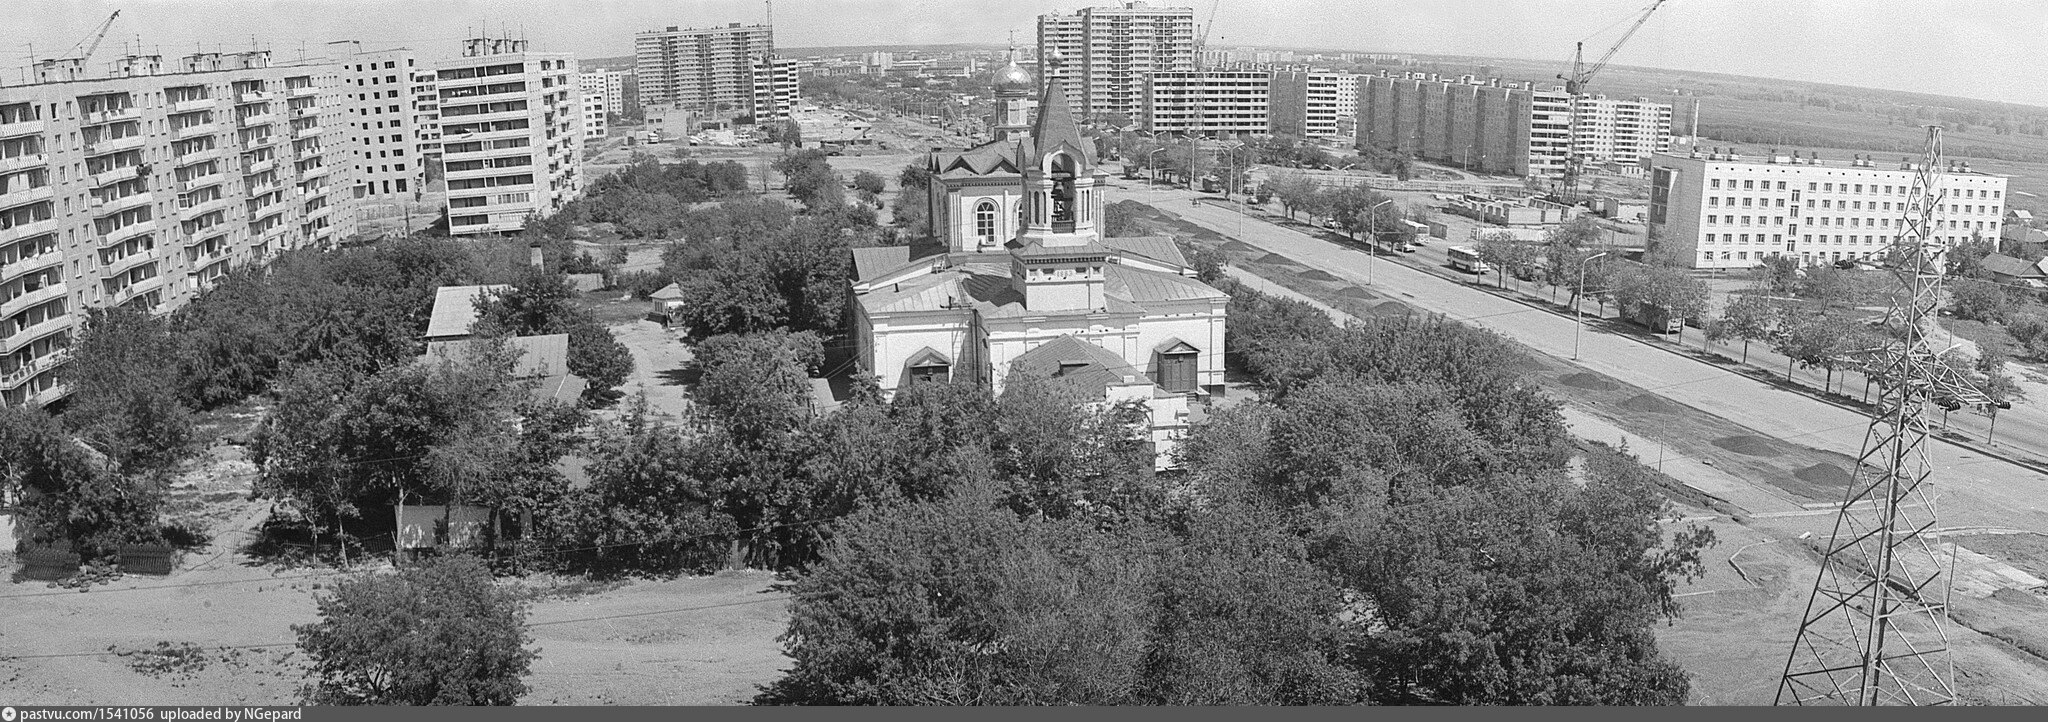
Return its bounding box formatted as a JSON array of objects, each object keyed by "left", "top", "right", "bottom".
[{"left": 338, "top": 47, "right": 426, "bottom": 200}]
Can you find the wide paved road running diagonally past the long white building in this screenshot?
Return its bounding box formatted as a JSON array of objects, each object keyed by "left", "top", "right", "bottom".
[{"left": 1137, "top": 190, "right": 2048, "bottom": 530}]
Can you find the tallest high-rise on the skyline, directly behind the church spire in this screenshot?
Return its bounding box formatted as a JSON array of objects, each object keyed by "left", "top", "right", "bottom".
[{"left": 1038, "top": 2, "right": 1198, "bottom": 121}]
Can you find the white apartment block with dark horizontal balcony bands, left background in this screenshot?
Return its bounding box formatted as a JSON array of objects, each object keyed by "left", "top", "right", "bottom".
[{"left": 434, "top": 39, "right": 584, "bottom": 235}]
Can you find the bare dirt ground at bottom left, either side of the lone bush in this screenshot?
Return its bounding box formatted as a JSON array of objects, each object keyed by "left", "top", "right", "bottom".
[{"left": 0, "top": 421, "right": 788, "bottom": 706}]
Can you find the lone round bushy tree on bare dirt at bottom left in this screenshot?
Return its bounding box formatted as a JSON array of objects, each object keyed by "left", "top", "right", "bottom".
[{"left": 293, "top": 556, "right": 541, "bottom": 706}]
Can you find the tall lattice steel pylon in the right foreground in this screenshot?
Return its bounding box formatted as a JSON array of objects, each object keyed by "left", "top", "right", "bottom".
[{"left": 1778, "top": 125, "right": 1991, "bottom": 706}]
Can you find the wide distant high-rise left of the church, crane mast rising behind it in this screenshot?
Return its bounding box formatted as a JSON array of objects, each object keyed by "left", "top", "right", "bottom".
[{"left": 633, "top": 22, "right": 774, "bottom": 119}]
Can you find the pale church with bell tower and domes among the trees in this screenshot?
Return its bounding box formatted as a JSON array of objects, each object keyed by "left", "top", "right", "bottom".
[{"left": 848, "top": 59, "right": 1229, "bottom": 466}]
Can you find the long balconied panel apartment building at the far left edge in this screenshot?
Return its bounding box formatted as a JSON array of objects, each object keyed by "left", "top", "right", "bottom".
[{"left": 0, "top": 51, "right": 354, "bottom": 405}]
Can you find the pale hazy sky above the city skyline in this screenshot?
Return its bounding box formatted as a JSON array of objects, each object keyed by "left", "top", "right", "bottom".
[{"left": 16, "top": 0, "right": 2048, "bottom": 106}]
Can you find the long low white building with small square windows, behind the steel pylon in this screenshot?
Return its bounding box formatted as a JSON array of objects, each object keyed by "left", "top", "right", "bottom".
[{"left": 1649, "top": 149, "right": 2005, "bottom": 268}]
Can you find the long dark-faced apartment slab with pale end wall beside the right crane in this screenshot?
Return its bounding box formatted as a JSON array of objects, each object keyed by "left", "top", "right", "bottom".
[{"left": 1358, "top": 72, "right": 1571, "bottom": 176}]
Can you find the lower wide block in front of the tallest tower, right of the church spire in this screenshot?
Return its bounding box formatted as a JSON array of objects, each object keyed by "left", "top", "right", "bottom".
[{"left": 1137, "top": 70, "right": 1274, "bottom": 135}]
